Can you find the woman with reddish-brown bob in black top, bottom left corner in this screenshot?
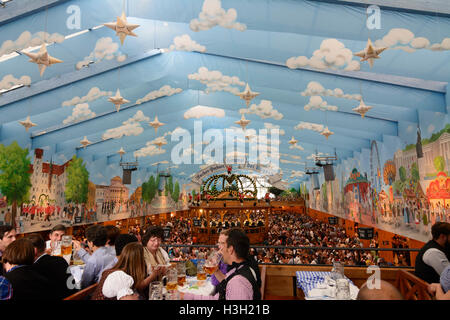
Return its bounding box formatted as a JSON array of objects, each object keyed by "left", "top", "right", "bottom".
[{"left": 3, "top": 238, "right": 54, "bottom": 300}]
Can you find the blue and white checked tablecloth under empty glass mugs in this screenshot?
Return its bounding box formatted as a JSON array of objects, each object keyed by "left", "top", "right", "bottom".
[{"left": 296, "top": 271, "right": 359, "bottom": 300}]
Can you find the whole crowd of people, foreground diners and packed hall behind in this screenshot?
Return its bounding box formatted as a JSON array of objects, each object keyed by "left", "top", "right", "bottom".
[{"left": 0, "top": 214, "right": 450, "bottom": 300}]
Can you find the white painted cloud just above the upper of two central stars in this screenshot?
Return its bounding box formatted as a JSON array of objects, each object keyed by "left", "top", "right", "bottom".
[{"left": 188, "top": 67, "right": 245, "bottom": 94}]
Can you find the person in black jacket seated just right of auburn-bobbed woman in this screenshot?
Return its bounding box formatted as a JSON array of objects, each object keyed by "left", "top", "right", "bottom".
[{"left": 27, "top": 234, "right": 76, "bottom": 300}]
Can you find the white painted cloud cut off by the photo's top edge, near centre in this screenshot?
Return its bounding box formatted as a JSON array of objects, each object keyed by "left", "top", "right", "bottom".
[{"left": 189, "top": 0, "right": 247, "bottom": 32}]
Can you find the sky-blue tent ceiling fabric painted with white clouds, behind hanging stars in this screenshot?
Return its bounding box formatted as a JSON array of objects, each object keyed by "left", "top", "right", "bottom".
[{"left": 0, "top": 0, "right": 450, "bottom": 188}]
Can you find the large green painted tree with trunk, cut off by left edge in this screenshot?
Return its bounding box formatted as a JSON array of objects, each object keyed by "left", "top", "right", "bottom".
[{"left": 0, "top": 141, "right": 31, "bottom": 227}]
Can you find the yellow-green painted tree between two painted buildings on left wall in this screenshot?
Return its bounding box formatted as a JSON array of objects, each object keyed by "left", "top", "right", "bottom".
[{"left": 65, "top": 155, "right": 89, "bottom": 204}]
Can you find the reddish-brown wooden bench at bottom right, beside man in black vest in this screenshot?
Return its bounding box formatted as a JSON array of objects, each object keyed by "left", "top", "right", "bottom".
[{"left": 395, "top": 270, "right": 434, "bottom": 300}]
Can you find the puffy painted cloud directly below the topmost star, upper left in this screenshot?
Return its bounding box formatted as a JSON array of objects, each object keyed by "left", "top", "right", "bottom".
[{"left": 75, "top": 37, "right": 126, "bottom": 70}]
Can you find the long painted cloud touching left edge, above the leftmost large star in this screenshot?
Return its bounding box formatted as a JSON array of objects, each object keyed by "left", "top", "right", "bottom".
[{"left": 0, "top": 31, "right": 65, "bottom": 57}]
